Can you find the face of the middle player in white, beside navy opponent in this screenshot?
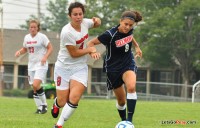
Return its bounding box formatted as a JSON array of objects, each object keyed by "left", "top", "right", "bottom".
[{"left": 70, "top": 8, "right": 84, "bottom": 25}]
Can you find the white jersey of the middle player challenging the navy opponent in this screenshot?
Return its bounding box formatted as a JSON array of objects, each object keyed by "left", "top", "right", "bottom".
[{"left": 56, "top": 18, "right": 94, "bottom": 67}]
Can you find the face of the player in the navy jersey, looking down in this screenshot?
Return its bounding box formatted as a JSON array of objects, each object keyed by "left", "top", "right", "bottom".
[{"left": 118, "top": 18, "right": 136, "bottom": 33}]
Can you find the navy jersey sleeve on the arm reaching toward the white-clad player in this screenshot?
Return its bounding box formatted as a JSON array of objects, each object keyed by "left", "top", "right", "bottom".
[{"left": 97, "top": 31, "right": 111, "bottom": 45}]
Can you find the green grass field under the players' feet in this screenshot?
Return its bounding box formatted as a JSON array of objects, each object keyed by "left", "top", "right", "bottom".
[{"left": 0, "top": 97, "right": 200, "bottom": 128}]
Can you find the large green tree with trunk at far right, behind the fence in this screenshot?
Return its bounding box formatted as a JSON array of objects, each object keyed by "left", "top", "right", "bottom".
[{"left": 140, "top": 0, "right": 200, "bottom": 96}]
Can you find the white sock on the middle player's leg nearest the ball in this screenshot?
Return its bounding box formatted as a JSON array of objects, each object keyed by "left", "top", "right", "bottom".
[{"left": 57, "top": 103, "right": 77, "bottom": 126}]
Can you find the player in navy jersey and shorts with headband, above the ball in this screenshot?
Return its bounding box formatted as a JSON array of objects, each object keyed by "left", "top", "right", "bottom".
[{"left": 88, "top": 11, "right": 142, "bottom": 122}]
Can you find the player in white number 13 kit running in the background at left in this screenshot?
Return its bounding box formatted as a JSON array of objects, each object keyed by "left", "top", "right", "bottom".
[{"left": 15, "top": 20, "right": 53, "bottom": 114}]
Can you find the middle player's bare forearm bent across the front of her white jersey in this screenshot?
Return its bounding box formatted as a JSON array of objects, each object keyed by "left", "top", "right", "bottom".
[{"left": 66, "top": 45, "right": 96, "bottom": 58}]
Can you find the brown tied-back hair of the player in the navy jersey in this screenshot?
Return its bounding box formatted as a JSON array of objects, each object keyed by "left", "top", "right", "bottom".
[{"left": 121, "top": 11, "right": 142, "bottom": 22}]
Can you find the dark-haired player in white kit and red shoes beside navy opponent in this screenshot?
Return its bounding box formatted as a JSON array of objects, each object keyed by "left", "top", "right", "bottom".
[{"left": 51, "top": 2, "right": 101, "bottom": 128}]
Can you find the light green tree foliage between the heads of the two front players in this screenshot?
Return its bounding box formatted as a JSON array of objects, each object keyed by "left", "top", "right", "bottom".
[{"left": 86, "top": 0, "right": 135, "bottom": 34}]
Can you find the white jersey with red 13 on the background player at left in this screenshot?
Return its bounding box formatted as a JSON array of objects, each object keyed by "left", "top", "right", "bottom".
[{"left": 23, "top": 32, "right": 49, "bottom": 71}]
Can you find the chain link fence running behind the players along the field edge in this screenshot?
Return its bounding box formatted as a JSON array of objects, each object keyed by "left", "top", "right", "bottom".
[{"left": 3, "top": 74, "right": 197, "bottom": 101}]
